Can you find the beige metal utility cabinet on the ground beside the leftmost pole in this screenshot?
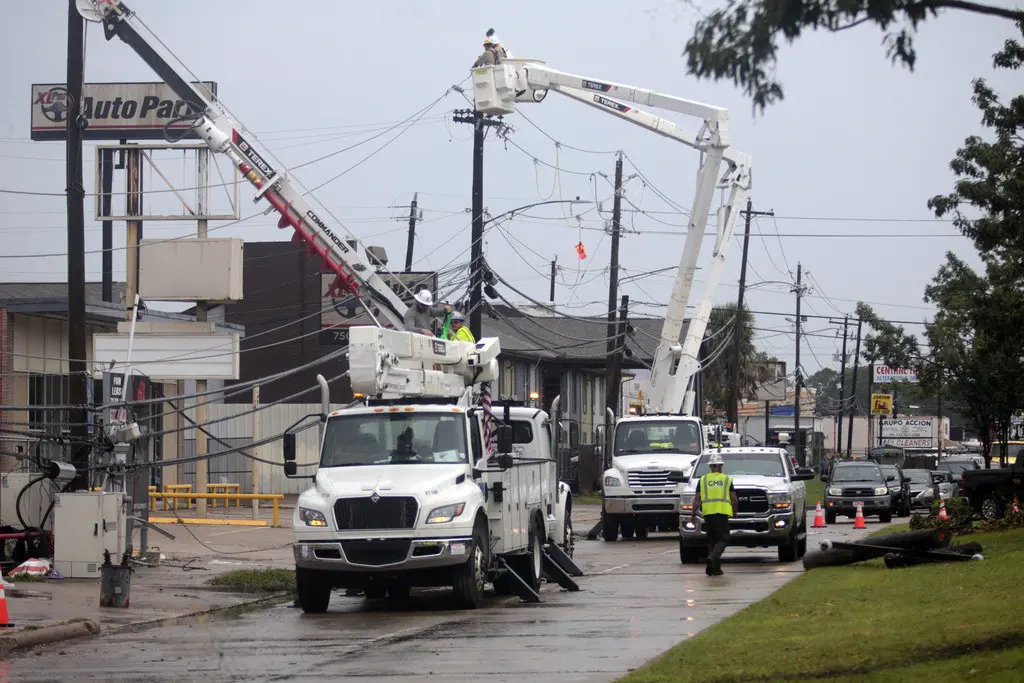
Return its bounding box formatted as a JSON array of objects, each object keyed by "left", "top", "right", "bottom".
[{"left": 53, "top": 492, "right": 127, "bottom": 579}]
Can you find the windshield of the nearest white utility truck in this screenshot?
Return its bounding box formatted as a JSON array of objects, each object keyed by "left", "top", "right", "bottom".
[{"left": 321, "top": 413, "right": 468, "bottom": 467}]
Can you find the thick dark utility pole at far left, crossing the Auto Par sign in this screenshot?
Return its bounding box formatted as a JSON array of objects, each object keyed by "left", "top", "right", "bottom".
[{"left": 65, "top": 0, "right": 90, "bottom": 490}]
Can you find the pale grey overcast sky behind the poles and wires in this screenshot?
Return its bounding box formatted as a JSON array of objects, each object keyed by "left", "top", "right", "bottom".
[{"left": 0, "top": 0, "right": 1021, "bottom": 374}]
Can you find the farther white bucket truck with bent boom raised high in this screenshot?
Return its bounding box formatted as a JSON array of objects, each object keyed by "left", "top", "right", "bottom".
[{"left": 472, "top": 58, "right": 751, "bottom": 541}]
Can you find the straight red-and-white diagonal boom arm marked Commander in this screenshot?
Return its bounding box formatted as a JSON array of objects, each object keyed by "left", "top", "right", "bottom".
[{"left": 78, "top": 0, "right": 407, "bottom": 330}]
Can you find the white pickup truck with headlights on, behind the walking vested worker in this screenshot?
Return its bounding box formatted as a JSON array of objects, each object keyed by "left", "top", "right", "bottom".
[{"left": 671, "top": 446, "right": 814, "bottom": 563}]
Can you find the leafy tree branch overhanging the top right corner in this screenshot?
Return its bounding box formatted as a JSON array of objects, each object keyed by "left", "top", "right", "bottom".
[{"left": 685, "top": 0, "right": 1024, "bottom": 111}]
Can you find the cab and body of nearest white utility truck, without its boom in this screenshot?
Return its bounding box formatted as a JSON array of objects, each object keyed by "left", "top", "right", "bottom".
[{"left": 285, "top": 401, "right": 582, "bottom": 612}]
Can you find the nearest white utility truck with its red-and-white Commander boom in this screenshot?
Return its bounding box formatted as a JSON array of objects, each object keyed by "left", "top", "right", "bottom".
[{"left": 78, "top": 0, "right": 583, "bottom": 612}]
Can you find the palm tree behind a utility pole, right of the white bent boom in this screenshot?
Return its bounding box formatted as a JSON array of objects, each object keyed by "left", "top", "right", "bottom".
[{"left": 702, "top": 303, "right": 776, "bottom": 422}]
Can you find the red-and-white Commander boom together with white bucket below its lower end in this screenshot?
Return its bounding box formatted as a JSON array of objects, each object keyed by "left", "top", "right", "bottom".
[{"left": 77, "top": 0, "right": 501, "bottom": 398}]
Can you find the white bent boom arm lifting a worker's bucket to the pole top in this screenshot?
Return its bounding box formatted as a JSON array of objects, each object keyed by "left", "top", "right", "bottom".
[{"left": 472, "top": 58, "right": 751, "bottom": 414}]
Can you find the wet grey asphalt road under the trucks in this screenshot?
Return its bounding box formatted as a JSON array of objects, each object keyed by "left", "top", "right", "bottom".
[{"left": 7, "top": 511, "right": 883, "bottom": 683}]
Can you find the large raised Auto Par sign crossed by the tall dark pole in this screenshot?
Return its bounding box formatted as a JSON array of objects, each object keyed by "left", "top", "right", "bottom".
[{"left": 31, "top": 81, "right": 217, "bottom": 140}]
